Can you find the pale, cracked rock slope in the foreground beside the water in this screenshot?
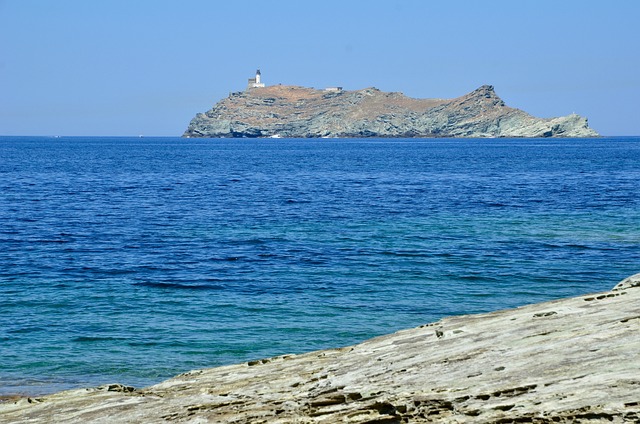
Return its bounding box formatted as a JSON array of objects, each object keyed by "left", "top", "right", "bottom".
[{"left": 0, "top": 274, "right": 640, "bottom": 424}]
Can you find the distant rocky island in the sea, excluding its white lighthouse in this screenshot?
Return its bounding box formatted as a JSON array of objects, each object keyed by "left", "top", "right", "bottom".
[{"left": 183, "top": 85, "right": 598, "bottom": 138}]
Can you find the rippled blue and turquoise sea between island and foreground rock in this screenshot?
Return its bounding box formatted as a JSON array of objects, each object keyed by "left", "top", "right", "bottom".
[{"left": 0, "top": 137, "right": 640, "bottom": 394}]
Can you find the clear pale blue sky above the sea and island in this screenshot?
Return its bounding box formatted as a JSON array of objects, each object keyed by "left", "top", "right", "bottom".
[{"left": 0, "top": 0, "right": 640, "bottom": 136}]
